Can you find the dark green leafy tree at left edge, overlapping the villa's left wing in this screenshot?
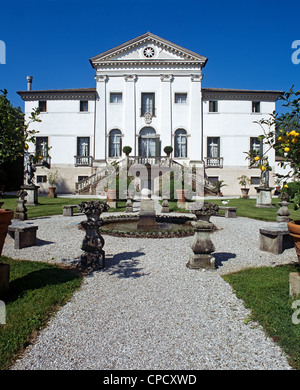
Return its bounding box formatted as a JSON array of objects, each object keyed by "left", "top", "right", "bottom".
[{"left": 0, "top": 90, "right": 41, "bottom": 165}]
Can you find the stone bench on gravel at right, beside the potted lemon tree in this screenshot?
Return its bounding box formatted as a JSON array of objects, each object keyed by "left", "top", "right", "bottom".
[{"left": 259, "top": 224, "right": 294, "bottom": 255}]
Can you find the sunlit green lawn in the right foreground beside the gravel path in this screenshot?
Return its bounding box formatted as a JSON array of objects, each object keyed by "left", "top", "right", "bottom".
[{"left": 223, "top": 264, "right": 300, "bottom": 370}]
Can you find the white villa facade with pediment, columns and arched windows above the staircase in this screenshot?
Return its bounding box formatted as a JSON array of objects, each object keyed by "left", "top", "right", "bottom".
[{"left": 19, "top": 33, "right": 280, "bottom": 195}]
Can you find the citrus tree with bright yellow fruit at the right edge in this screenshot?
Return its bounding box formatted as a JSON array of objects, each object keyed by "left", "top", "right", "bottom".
[{"left": 248, "top": 86, "right": 300, "bottom": 210}]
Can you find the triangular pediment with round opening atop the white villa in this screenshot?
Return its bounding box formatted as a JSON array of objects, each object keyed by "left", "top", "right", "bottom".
[{"left": 90, "top": 32, "right": 207, "bottom": 67}]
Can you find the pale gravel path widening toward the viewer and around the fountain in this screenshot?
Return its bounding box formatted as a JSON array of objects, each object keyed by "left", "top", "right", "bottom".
[{"left": 3, "top": 215, "right": 296, "bottom": 370}]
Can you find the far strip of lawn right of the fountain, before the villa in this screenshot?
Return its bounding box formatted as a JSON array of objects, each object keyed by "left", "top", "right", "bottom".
[{"left": 169, "top": 197, "right": 300, "bottom": 221}]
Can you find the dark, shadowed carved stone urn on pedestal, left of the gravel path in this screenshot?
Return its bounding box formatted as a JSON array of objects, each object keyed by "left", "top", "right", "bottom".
[{"left": 78, "top": 201, "right": 109, "bottom": 272}]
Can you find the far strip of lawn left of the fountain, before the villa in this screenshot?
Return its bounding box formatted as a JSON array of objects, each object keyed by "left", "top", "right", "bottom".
[{"left": 0, "top": 196, "right": 126, "bottom": 218}]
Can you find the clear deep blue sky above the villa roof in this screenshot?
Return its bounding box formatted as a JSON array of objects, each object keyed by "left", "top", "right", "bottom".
[{"left": 0, "top": 0, "right": 300, "bottom": 108}]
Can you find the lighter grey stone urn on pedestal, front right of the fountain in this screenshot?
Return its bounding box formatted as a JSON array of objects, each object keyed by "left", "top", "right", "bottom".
[{"left": 186, "top": 202, "right": 219, "bottom": 269}]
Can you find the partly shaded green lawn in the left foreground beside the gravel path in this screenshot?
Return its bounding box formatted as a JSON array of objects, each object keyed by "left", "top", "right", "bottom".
[{"left": 0, "top": 256, "right": 82, "bottom": 370}]
